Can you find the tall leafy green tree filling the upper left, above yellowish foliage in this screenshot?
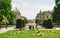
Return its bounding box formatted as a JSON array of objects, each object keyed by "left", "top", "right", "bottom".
[{"left": 0, "top": 0, "right": 16, "bottom": 25}]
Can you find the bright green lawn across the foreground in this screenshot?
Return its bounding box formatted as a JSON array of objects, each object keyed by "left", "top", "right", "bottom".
[{"left": 0, "top": 30, "right": 60, "bottom": 38}]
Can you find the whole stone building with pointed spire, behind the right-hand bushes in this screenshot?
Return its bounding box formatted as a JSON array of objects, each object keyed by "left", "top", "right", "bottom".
[{"left": 36, "top": 11, "right": 52, "bottom": 24}]
